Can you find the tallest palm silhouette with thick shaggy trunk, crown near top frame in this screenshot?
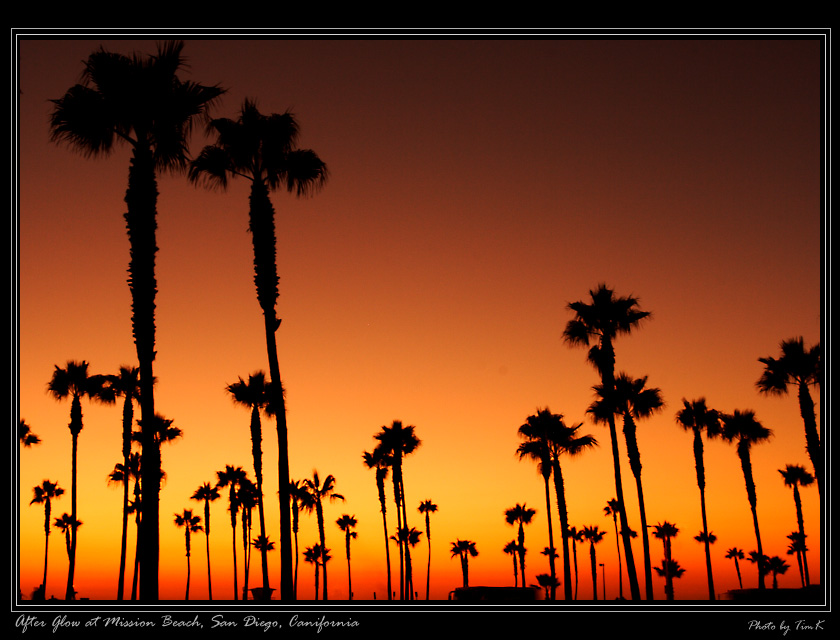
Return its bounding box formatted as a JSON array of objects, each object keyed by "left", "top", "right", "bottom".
[{"left": 50, "top": 42, "right": 223, "bottom": 600}]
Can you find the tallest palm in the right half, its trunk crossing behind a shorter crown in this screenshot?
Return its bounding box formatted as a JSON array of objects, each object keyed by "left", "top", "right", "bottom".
[{"left": 563, "top": 284, "right": 651, "bottom": 600}]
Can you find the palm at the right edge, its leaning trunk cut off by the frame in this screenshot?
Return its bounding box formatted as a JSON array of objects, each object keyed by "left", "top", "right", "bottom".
[{"left": 756, "top": 336, "right": 823, "bottom": 495}]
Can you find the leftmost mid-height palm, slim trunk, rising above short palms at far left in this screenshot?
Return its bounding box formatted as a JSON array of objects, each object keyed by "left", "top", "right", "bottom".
[{"left": 47, "top": 360, "right": 114, "bottom": 600}]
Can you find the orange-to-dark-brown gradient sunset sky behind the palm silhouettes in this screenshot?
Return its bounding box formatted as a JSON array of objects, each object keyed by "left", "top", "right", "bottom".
[{"left": 15, "top": 36, "right": 825, "bottom": 600}]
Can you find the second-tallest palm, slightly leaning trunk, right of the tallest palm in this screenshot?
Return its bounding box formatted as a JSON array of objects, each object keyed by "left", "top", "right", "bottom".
[{"left": 189, "top": 100, "right": 328, "bottom": 600}]
